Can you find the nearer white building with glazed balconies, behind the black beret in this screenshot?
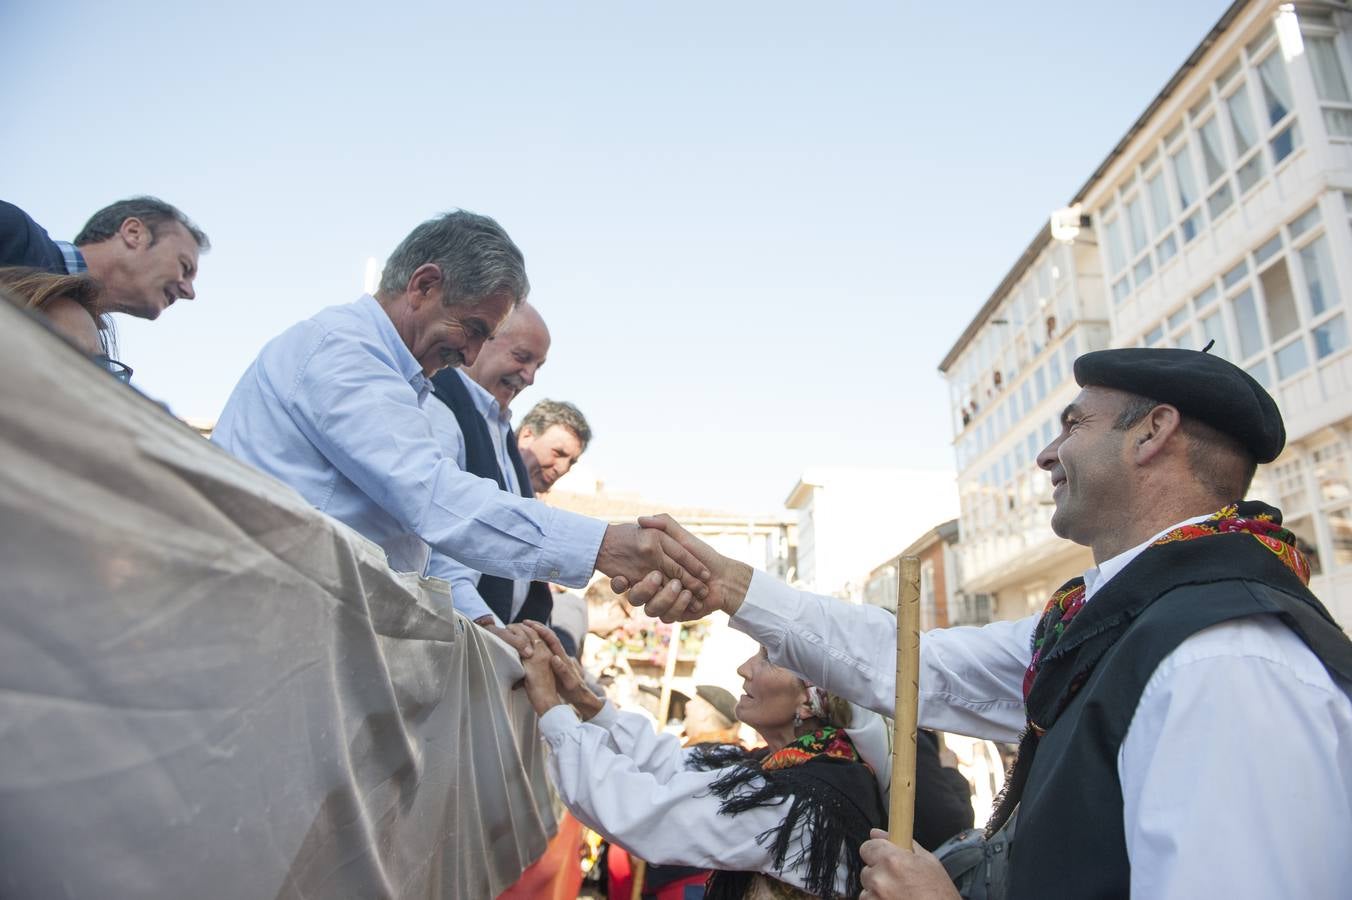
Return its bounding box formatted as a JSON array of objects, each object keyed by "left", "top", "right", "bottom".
[{"left": 1075, "top": 3, "right": 1352, "bottom": 620}]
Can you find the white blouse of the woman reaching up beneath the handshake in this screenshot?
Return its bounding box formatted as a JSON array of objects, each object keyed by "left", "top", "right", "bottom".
[{"left": 539, "top": 703, "right": 846, "bottom": 892}]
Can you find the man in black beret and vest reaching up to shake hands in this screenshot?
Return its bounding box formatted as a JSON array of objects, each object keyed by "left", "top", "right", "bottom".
[{"left": 630, "top": 349, "right": 1352, "bottom": 900}]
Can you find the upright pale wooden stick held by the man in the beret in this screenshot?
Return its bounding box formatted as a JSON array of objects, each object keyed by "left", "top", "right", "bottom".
[{"left": 887, "top": 557, "right": 921, "bottom": 853}]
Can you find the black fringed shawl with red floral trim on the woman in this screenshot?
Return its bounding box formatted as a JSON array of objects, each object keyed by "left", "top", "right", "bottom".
[{"left": 690, "top": 727, "right": 887, "bottom": 900}]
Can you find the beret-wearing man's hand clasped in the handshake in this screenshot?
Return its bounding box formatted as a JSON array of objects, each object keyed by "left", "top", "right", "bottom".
[{"left": 611, "top": 514, "right": 752, "bottom": 622}]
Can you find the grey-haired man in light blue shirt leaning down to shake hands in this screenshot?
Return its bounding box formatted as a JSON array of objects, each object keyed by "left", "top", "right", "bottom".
[{"left": 212, "top": 211, "right": 706, "bottom": 655}]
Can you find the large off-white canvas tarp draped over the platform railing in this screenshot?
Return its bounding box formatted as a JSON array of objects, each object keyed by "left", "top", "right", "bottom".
[{"left": 0, "top": 303, "right": 553, "bottom": 900}]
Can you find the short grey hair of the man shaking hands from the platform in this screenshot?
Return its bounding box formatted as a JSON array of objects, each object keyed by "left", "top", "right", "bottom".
[{"left": 380, "top": 209, "right": 530, "bottom": 307}]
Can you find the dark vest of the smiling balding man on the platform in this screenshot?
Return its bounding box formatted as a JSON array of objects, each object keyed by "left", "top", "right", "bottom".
[{"left": 421, "top": 369, "right": 554, "bottom": 623}]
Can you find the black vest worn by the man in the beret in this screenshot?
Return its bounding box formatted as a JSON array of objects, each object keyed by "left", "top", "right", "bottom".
[{"left": 1007, "top": 534, "right": 1352, "bottom": 900}]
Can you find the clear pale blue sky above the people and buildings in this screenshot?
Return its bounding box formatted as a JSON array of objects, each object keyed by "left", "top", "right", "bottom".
[{"left": 0, "top": 0, "right": 1229, "bottom": 512}]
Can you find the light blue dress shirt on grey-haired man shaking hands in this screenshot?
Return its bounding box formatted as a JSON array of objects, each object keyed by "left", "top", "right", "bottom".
[{"left": 212, "top": 295, "right": 606, "bottom": 602}]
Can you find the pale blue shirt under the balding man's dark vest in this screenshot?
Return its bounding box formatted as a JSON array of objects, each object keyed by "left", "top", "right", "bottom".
[{"left": 425, "top": 369, "right": 530, "bottom": 626}]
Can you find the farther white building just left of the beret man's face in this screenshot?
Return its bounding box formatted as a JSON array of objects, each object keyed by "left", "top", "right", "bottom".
[{"left": 940, "top": 227, "right": 1109, "bottom": 623}]
